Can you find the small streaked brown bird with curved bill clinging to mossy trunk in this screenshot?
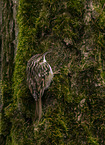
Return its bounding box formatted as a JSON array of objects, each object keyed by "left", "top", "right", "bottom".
[{"left": 26, "top": 52, "right": 53, "bottom": 120}]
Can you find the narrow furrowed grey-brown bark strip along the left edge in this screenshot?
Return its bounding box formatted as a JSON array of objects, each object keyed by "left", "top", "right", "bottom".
[{"left": 0, "top": 0, "right": 15, "bottom": 145}]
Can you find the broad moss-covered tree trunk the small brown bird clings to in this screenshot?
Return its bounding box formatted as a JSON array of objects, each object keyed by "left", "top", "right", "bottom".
[{"left": 0, "top": 0, "right": 105, "bottom": 145}]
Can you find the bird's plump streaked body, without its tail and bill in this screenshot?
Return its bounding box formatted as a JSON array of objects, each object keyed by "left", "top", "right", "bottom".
[{"left": 27, "top": 54, "right": 51, "bottom": 101}]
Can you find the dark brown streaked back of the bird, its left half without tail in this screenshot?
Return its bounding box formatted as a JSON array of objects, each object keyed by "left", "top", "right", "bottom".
[{"left": 26, "top": 55, "right": 44, "bottom": 101}]
